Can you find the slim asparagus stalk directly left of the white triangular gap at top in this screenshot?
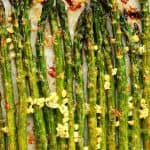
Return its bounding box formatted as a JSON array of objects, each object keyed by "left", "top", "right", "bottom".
[{"left": 59, "top": 0, "right": 75, "bottom": 150}]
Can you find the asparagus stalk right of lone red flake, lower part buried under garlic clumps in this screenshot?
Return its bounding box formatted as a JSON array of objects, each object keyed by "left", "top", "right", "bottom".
[{"left": 49, "top": 1, "right": 66, "bottom": 149}]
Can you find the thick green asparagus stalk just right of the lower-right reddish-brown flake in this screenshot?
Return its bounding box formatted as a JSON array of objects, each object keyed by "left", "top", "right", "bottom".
[{"left": 116, "top": 28, "right": 129, "bottom": 149}]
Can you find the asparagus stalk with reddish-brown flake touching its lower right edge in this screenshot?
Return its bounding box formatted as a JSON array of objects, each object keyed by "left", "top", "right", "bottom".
[{"left": 104, "top": 38, "right": 116, "bottom": 149}]
